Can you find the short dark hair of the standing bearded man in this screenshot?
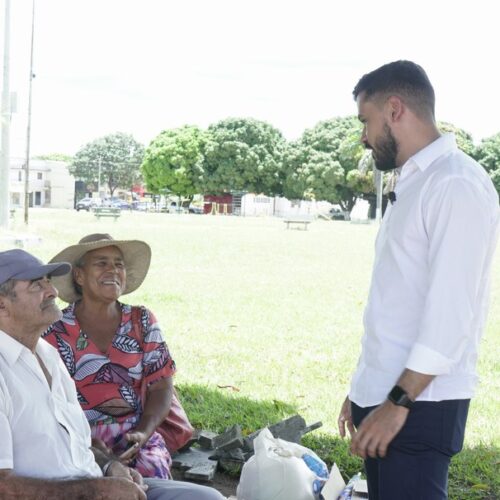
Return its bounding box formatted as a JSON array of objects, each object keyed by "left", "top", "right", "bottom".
[{"left": 352, "top": 61, "right": 436, "bottom": 120}]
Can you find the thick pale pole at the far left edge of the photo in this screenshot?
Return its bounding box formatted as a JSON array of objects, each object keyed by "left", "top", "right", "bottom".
[{"left": 0, "top": 0, "right": 11, "bottom": 229}]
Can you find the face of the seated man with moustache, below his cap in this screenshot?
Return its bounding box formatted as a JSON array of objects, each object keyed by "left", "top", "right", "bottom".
[{"left": 2, "top": 276, "right": 62, "bottom": 333}]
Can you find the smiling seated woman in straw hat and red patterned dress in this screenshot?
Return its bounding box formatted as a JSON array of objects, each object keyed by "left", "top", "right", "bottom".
[{"left": 44, "top": 234, "right": 219, "bottom": 499}]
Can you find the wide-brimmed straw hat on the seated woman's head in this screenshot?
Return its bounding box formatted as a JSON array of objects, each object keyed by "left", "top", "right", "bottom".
[{"left": 50, "top": 233, "right": 151, "bottom": 303}]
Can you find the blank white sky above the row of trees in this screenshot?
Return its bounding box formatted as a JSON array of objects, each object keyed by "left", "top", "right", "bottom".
[{"left": 0, "top": 0, "right": 500, "bottom": 157}]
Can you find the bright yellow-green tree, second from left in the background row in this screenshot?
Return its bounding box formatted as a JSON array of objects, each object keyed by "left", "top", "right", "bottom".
[{"left": 141, "top": 126, "right": 206, "bottom": 201}]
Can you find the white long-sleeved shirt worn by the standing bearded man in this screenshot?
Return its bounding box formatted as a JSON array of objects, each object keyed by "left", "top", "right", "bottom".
[{"left": 349, "top": 134, "right": 500, "bottom": 407}]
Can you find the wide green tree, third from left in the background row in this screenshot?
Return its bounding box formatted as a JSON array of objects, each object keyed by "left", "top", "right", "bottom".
[{"left": 203, "top": 118, "right": 286, "bottom": 196}]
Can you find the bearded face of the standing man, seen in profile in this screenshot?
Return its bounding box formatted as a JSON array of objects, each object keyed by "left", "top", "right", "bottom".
[{"left": 357, "top": 94, "right": 399, "bottom": 171}]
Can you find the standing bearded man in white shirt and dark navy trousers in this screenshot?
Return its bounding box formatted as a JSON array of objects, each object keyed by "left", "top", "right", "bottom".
[{"left": 338, "top": 61, "right": 500, "bottom": 500}]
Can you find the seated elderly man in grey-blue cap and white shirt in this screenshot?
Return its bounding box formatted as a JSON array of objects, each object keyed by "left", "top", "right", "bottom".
[{"left": 0, "top": 249, "right": 224, "bottom": 500}]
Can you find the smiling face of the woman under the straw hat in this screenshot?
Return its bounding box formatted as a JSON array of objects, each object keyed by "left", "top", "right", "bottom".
[{"left": 74, "top": 246, "right": 127, "bottom": 302}]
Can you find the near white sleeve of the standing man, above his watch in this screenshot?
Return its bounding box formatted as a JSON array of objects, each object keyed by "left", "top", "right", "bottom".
[{"left": 406, "top": 177, "right": 492, "bottom": 375}]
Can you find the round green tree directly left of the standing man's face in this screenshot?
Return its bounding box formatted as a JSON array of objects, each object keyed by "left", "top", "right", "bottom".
[{"left": 284, "top": 116, "right": 374, "bottom": 212}]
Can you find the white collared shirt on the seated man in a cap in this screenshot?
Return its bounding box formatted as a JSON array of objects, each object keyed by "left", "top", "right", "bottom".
[{"left": 0, "top": 330, "right": 102, "bottom": 479}]
